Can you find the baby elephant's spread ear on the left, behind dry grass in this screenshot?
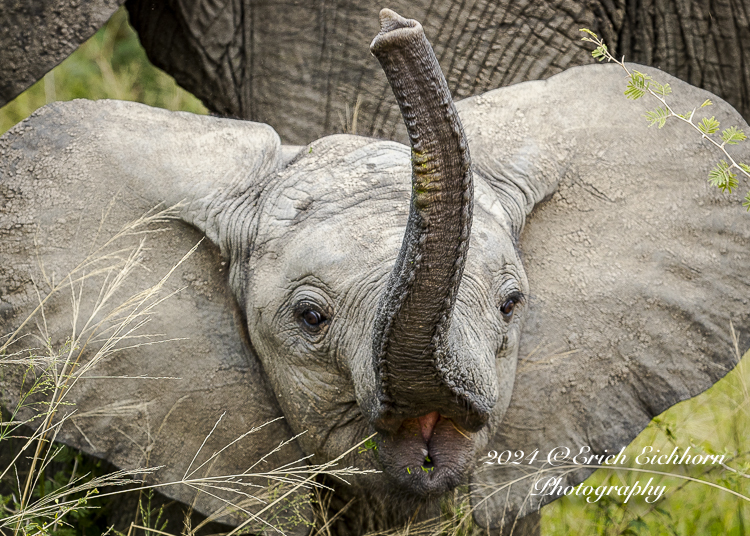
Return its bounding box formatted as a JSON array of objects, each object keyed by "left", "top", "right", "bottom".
[{"left": 0, "top": 101, "right": 307, "bottom": 523}]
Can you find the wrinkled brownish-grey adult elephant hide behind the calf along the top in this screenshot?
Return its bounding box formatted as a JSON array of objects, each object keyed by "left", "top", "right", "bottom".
[{"left": 0, "top": 0, "right": 750, "bottom": 143}]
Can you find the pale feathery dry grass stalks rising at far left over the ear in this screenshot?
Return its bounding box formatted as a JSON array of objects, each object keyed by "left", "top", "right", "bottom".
[{"left": 0, "top": 207, "right": 198, "bottom": 534}]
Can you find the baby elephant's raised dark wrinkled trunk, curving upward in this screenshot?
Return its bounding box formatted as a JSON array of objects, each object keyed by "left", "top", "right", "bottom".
[{"left": 370, "top": 9, "right": 482, "bottom": 431}]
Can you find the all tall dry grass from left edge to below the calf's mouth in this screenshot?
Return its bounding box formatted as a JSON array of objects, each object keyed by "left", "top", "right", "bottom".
[{"left": 0, "top": 208, "right": 372, "bottom": 536}]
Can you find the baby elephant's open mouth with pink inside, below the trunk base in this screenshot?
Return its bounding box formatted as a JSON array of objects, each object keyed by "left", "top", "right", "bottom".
[{"left": 379, "top": 411, "right": 474, "bottom": 498}]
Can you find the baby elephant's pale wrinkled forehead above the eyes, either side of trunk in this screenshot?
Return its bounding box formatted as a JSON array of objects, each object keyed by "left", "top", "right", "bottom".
[{"left": 256, "top": 135, "right": 517, "bottom": 281}]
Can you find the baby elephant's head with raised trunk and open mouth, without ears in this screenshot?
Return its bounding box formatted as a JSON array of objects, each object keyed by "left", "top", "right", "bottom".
[{"left": 244, "top": 10, "right": 527, "bottom": 496}]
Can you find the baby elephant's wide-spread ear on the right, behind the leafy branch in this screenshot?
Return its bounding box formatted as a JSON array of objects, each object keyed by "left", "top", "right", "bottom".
[{"left": 458, "top": 65, "right": 750, "bottom": 530}]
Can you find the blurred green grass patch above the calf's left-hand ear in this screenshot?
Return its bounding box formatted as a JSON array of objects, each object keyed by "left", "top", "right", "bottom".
[{"left": 0, "top": 8, "right": 207, "bottom": 134}]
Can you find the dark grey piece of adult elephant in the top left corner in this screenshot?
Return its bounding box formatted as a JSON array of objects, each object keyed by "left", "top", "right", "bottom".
[{"left": 0, "top": 0, "right": 125, "bottom": 106}]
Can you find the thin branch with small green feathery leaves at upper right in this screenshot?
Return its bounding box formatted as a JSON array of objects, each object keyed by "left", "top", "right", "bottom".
[{"left": 580, "top": 28, "right": 750, "bottom": 211}]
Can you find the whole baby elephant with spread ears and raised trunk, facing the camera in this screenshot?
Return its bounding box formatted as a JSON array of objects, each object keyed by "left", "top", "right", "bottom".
[{"left": 0, "top": 10, "right": 750, "bottom": 534}]
